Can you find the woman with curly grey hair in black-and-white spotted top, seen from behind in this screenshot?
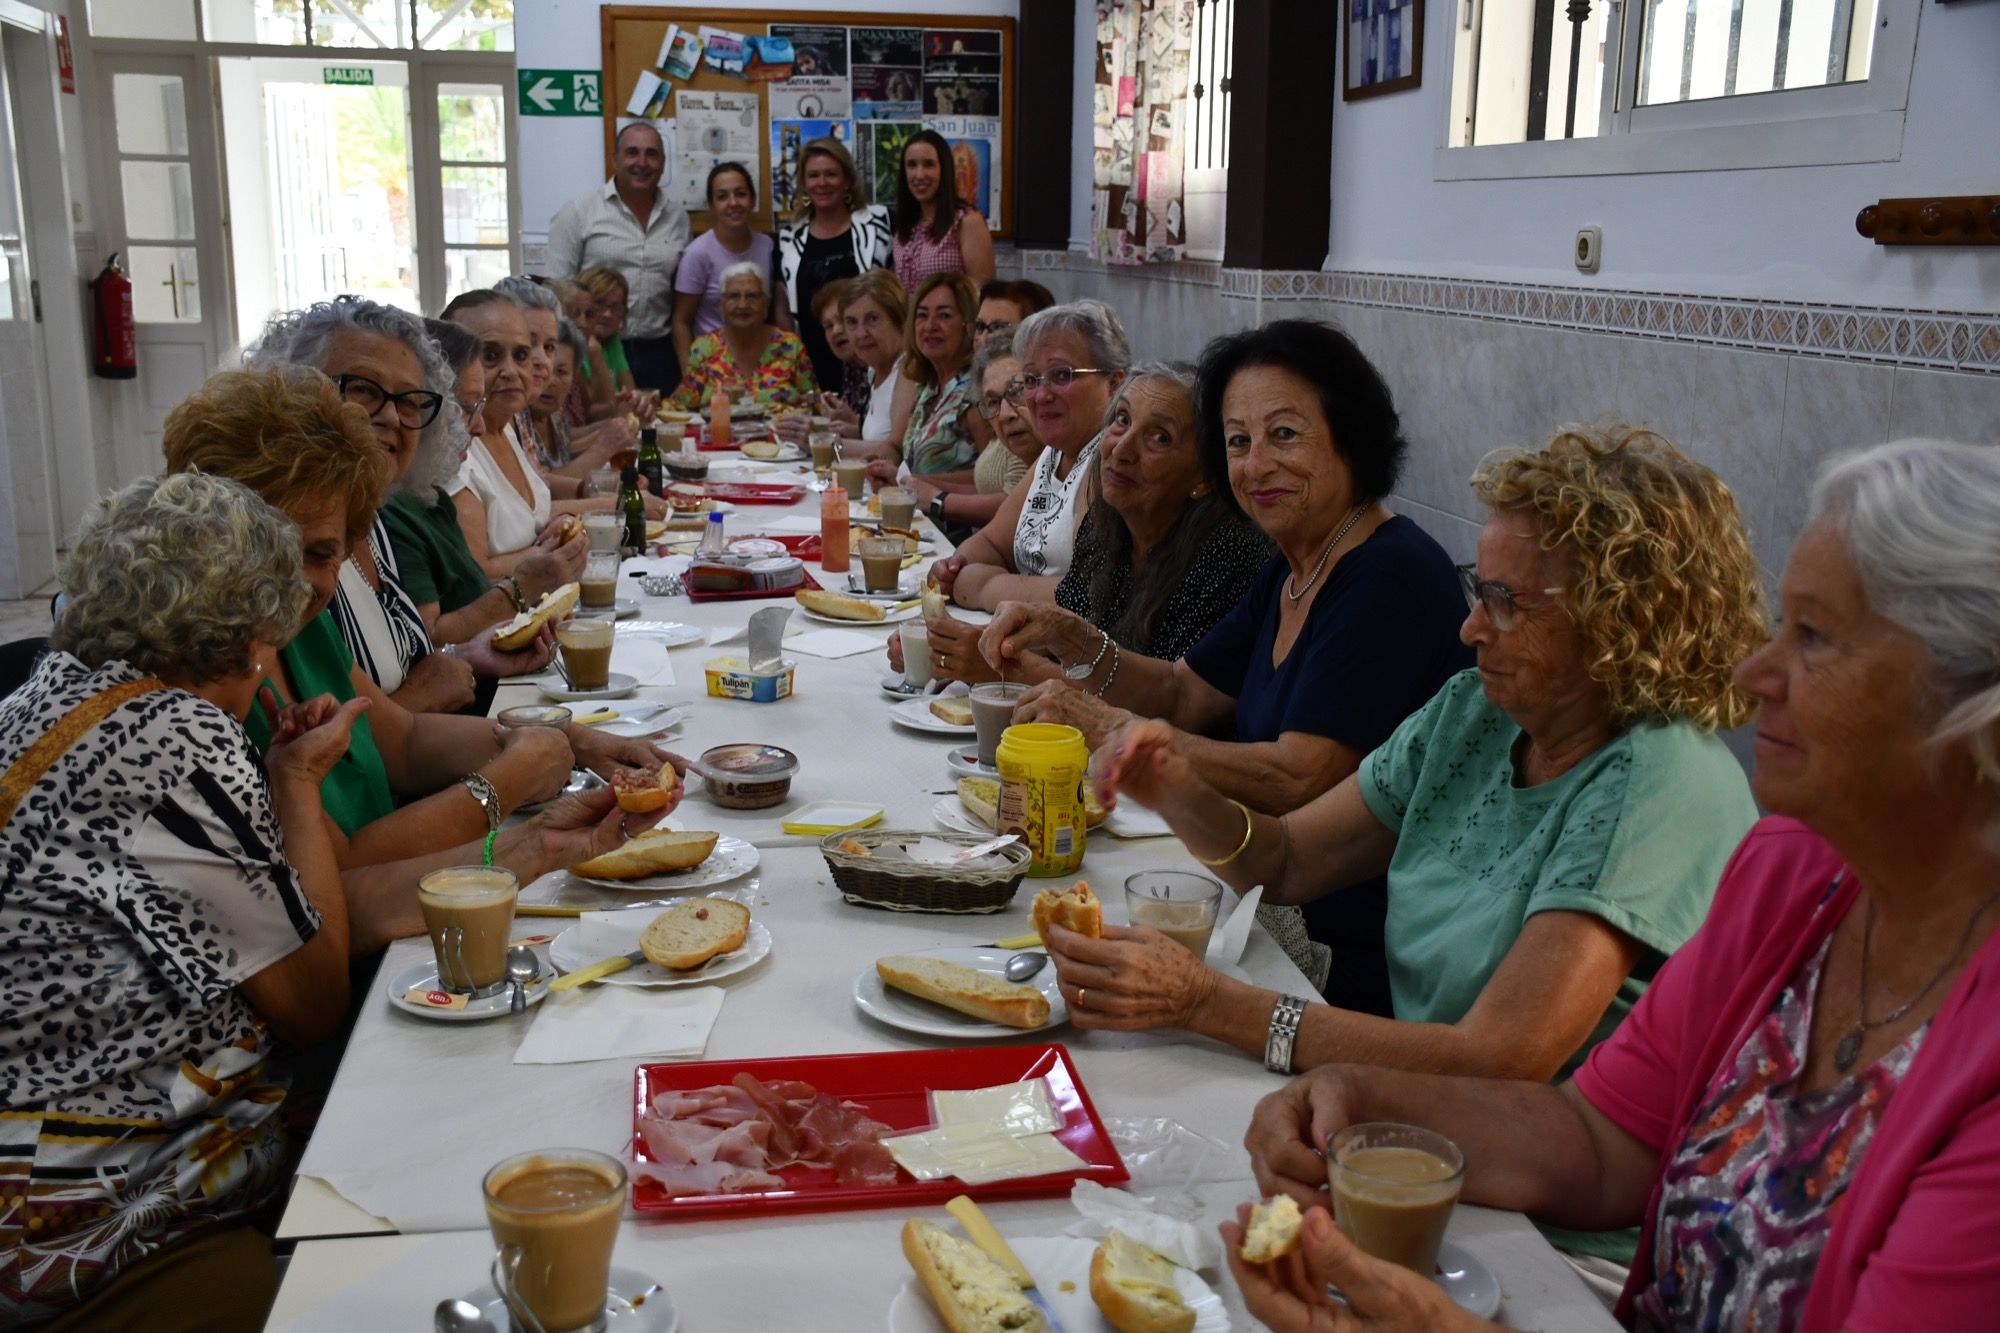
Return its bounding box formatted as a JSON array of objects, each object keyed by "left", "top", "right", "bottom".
[{"left": 0, "top": 474, "right": 360, "bottom": 1329}]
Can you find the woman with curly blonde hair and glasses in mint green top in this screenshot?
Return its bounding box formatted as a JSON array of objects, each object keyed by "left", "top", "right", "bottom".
[{"left": 1048, "top": 428, "right": 1764, "bottom": 1259}]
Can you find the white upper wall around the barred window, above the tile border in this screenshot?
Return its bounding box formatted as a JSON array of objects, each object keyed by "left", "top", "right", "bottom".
[{"left": 1328, "top": 0, "right": 2000, "bottom": 310}]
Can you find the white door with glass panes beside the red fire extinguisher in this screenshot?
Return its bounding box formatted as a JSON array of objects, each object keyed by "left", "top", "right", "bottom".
[{"left": 96, "top": 48, "right": 236, "bottom": 484}]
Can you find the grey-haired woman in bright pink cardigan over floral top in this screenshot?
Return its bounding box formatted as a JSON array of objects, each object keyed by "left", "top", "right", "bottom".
[{"left": 1224, "top": 440, "right": 2000, "bottom": 1333}]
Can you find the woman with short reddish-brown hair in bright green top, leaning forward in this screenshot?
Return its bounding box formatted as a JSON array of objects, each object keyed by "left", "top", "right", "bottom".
[{"left": 164, "top": 366, "right": 688, "bottom": 953}]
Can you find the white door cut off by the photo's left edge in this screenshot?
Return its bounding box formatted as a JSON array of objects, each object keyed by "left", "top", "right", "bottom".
[{"left": 0, "top": 15, "right": 58, "bottom": 598}]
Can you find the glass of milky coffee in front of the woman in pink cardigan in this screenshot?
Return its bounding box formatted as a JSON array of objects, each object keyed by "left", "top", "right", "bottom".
[{"left": 1326, "top": 1121, "right": 1466, "bottom": 1277}]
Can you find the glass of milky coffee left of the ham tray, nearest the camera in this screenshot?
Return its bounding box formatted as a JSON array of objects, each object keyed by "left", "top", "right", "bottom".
[{"left": 482, "top": 1149, "right": 626, "bottom": 1333}]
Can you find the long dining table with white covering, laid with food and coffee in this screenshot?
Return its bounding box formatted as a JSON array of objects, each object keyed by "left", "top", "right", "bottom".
[{"left": 268, "top": 454, "right": 1616, "bottom": 1333}]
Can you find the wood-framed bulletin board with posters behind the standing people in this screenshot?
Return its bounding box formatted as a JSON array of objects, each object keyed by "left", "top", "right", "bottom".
[{"left": 600, "top": 4, "right": 1016, "bottom": 236}]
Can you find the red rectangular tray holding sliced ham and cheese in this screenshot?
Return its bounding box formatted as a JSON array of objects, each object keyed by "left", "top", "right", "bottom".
[{"left": 632, "top": 1043, "right": 1132, "bottom": 1219}]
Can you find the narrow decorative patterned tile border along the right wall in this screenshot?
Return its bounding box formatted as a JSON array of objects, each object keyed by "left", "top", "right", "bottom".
[{"left": 1020, "top": 250, "right": 2000, "bottom": 374}]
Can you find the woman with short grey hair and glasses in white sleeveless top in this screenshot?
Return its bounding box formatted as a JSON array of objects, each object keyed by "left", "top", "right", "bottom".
[{"left": 930, "top": 300, "right": 1132, "bottom": 610}]
